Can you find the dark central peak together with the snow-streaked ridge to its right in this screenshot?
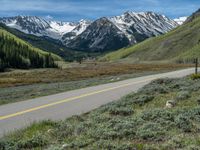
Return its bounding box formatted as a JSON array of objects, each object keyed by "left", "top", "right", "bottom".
[{"left": 63, "top": 12, "right": 178, "bottom": 51}]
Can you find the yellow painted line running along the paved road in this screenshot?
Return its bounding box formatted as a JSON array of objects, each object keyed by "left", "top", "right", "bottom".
[{"left": 0, "top": 77, "right": 162, "bottom": 121}]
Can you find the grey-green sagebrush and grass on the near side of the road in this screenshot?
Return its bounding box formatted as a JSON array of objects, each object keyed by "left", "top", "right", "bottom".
[{"left": 0, "top": 76, "right": 200, "bottom": 150}]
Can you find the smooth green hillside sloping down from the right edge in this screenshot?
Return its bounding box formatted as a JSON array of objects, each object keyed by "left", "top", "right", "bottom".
[{"left": 101, "top": 12, "right": 200, "bottom": 62}]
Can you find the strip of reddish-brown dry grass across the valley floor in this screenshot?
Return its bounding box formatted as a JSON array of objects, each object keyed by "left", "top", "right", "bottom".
[{"left": 0, "top": 63, "right": 191, "bottom": 87}]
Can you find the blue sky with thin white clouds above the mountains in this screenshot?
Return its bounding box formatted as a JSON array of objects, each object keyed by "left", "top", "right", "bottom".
[{"left": 0, "top": 0, "right": 200, "bottom": 21}]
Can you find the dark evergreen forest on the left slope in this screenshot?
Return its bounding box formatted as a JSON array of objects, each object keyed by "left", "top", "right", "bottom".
[{"left": 0, "top": 32, "right": 57, "bottom": 71}]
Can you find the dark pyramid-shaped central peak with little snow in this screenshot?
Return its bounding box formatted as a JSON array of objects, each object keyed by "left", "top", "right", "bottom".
[{"left": 64, "top": 17, "right": 129, "bottom": 51}]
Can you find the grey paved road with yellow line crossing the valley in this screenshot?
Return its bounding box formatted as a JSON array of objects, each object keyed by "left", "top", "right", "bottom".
[{"left": 0, "top": 69, "right": 194, "bottom": 137}]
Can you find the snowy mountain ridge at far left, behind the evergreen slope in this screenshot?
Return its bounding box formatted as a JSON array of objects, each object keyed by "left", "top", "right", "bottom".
[{"left": 0, "top": 16, "right": 83, "bottom": 39}]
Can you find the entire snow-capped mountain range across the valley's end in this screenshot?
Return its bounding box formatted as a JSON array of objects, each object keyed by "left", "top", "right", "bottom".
[{"left": 0, "top": 12, "right": 178, "bottom": 51}]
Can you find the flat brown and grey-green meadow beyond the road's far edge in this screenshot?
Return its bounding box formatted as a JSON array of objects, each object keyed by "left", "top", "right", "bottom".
[{"left": 0, "top": 62, "right": 190, "bottom": 105}]
